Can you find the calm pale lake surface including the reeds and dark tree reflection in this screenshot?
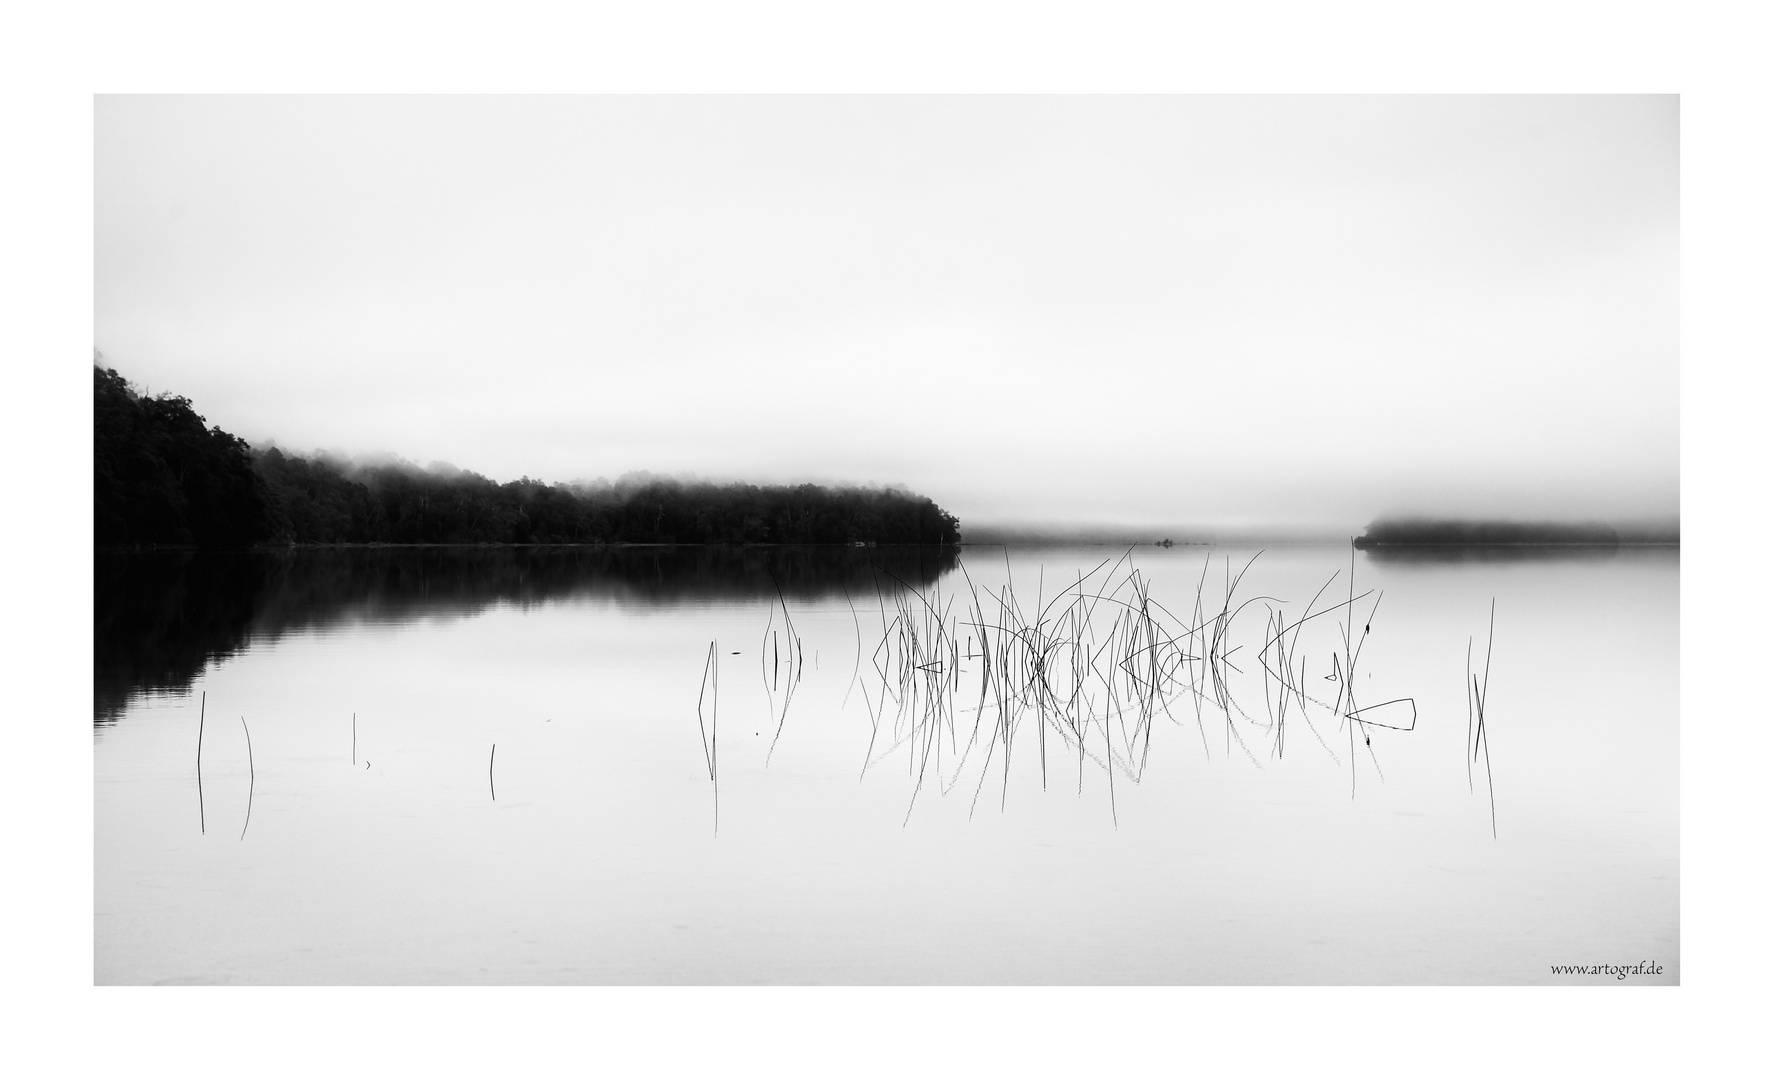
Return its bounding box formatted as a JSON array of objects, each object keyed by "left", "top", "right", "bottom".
[{"left": 94, "top": 546, "right": 1680, "bottom": 986}]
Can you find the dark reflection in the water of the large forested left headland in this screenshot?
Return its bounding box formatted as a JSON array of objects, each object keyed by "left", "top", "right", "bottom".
[{"left": 92, "top": 546, "right": 958, "bottom": 725}]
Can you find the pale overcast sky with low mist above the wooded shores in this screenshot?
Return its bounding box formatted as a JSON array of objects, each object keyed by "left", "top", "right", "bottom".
[{"left": 94, "top": 96, "right": 1680, "bottom": 528}]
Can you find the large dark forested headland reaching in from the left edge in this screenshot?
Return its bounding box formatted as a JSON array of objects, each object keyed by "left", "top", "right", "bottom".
[{"left": 92, "top": 364, "right": 962, "bottom": 548}]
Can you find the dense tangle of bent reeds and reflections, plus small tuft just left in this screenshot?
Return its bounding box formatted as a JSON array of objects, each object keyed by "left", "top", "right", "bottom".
[{"left": 741, "top": 548, "right": 1461, "bottom": 819}]
